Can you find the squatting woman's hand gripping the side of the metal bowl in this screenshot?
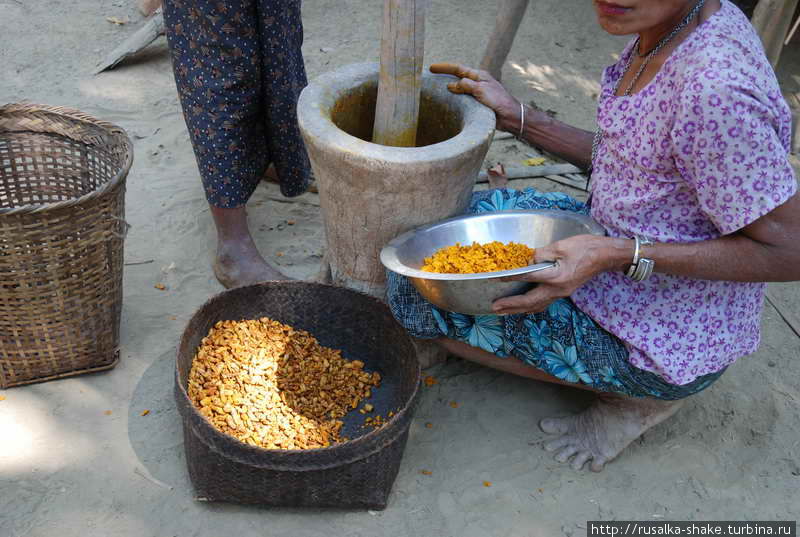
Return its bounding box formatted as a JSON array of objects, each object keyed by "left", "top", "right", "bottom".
[{"left": 492, "top": 235, "right": 614, "bottom": 315}]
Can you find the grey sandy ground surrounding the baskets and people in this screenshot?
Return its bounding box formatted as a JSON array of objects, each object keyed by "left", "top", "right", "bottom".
[{"left": 0, "top": 0, "right": 800, "bottom": 537}]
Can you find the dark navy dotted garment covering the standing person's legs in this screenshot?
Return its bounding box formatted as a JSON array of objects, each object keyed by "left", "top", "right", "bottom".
[{"left": 164, "top": 0, "right": 311, "bottom": 208}]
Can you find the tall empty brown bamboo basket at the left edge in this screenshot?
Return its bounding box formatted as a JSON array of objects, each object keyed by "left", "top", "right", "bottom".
[{"left": 0, "top": 104, "right": 133, "bottom": 388}]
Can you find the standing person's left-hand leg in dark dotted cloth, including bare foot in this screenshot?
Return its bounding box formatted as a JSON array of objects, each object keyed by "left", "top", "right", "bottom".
[{"left": 164, "top": 0, "right": 300, "bottom": 287}]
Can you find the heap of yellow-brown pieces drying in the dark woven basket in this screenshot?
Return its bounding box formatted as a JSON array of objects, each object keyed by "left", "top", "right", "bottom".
[{"left": 189, "top": 317, "right": 381, "bottom": 449}]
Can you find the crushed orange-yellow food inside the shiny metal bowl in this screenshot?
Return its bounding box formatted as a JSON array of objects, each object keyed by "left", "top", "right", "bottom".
[{"left": 420, "top": 241, "right": 535, "bottom": 274}]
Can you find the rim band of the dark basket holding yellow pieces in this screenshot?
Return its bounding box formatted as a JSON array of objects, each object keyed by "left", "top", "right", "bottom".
[{"left": 174, "top": 280, "right": 422, "bottom": 472}]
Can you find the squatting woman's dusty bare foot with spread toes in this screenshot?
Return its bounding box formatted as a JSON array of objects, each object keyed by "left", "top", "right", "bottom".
[{"left": 539, "top": 394, "right": 683, "bottom": 472}]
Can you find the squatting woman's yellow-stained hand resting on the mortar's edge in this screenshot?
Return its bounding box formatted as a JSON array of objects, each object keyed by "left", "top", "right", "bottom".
[{"left": 431, "top": 63, "right": 520, "bottom": 134}]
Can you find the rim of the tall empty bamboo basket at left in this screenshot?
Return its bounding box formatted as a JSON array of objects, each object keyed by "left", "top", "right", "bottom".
[{"left": 0, "top": 101, "right": 133, "bottom": 216}]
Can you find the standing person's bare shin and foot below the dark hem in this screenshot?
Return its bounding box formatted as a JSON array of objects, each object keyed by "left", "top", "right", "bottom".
[{"left": 211, "top": 206, "right": 291, "bottom": 289}]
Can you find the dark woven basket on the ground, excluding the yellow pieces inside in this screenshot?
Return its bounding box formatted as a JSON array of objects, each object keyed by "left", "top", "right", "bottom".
[{"left": 175, "top": 282, "right": 420, "bottom": 509}]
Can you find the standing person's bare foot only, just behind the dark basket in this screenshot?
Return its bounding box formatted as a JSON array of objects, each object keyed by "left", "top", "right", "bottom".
[{"left": 214, "top": 240, "right": 291, "bottom": 289}]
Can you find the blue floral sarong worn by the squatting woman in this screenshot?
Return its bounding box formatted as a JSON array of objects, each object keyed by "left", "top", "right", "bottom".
[{"left": 388, "top": 189, "right": 724, "bottom": 400}]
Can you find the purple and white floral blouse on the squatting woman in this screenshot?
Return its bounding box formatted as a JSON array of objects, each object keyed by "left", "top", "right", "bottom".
[{"left": 572, "top": 0, "right": 797, "bottom": 384}]
